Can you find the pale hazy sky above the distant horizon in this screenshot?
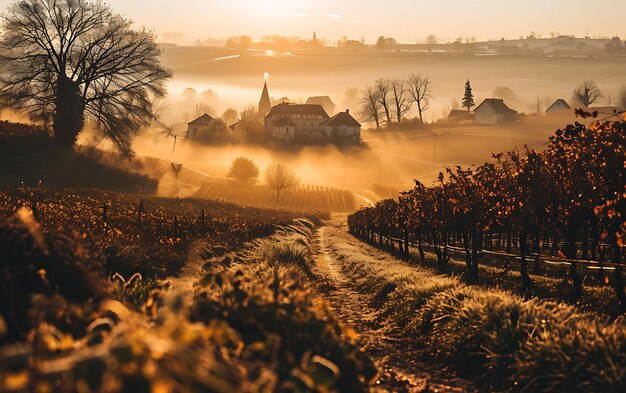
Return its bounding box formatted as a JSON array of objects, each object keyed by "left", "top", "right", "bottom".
[{"left": 0, "top": 0, "right": 626, "bottom": 43}]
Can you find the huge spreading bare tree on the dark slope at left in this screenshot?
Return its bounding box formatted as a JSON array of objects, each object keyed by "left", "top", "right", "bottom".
[{"left": 0, "top": 0, "right": 171, "bottom": 152}]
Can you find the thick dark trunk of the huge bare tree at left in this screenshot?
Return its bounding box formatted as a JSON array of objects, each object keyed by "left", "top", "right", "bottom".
[{"left": 53, "top": 75, "right": 85, "bottom": 148}]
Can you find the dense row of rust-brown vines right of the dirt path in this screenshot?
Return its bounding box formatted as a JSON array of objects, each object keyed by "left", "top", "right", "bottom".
[{"left": 348, "top": 112, "right": 626, "bottom": 312}]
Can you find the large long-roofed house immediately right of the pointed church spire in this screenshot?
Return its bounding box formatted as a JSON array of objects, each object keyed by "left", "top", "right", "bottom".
[{"left": 265, "top": 103, "right": 330, "bottom": 140}]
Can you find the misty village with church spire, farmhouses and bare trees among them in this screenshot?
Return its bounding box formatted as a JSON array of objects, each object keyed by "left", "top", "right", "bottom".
[{"left": 184, "top": 77, "right": 621, "bottom": 146}]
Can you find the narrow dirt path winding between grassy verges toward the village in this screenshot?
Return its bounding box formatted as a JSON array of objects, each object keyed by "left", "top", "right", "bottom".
[{"left": 313, "top": 216, "right": 475, "bottom": 392}]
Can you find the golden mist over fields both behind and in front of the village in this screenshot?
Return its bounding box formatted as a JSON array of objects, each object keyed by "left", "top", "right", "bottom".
[{"left": 130, "top": 46, "right": 626, "bottom": 198}]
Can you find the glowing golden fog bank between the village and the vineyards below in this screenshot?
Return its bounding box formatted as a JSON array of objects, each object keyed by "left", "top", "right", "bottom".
[{"left": 134, "top": 108, "right": 582, "bottom": 208}]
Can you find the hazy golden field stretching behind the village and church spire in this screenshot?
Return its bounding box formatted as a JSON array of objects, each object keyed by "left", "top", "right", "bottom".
[{"left": 163, "top": 47, "right": 626, "bottom": 119}]
